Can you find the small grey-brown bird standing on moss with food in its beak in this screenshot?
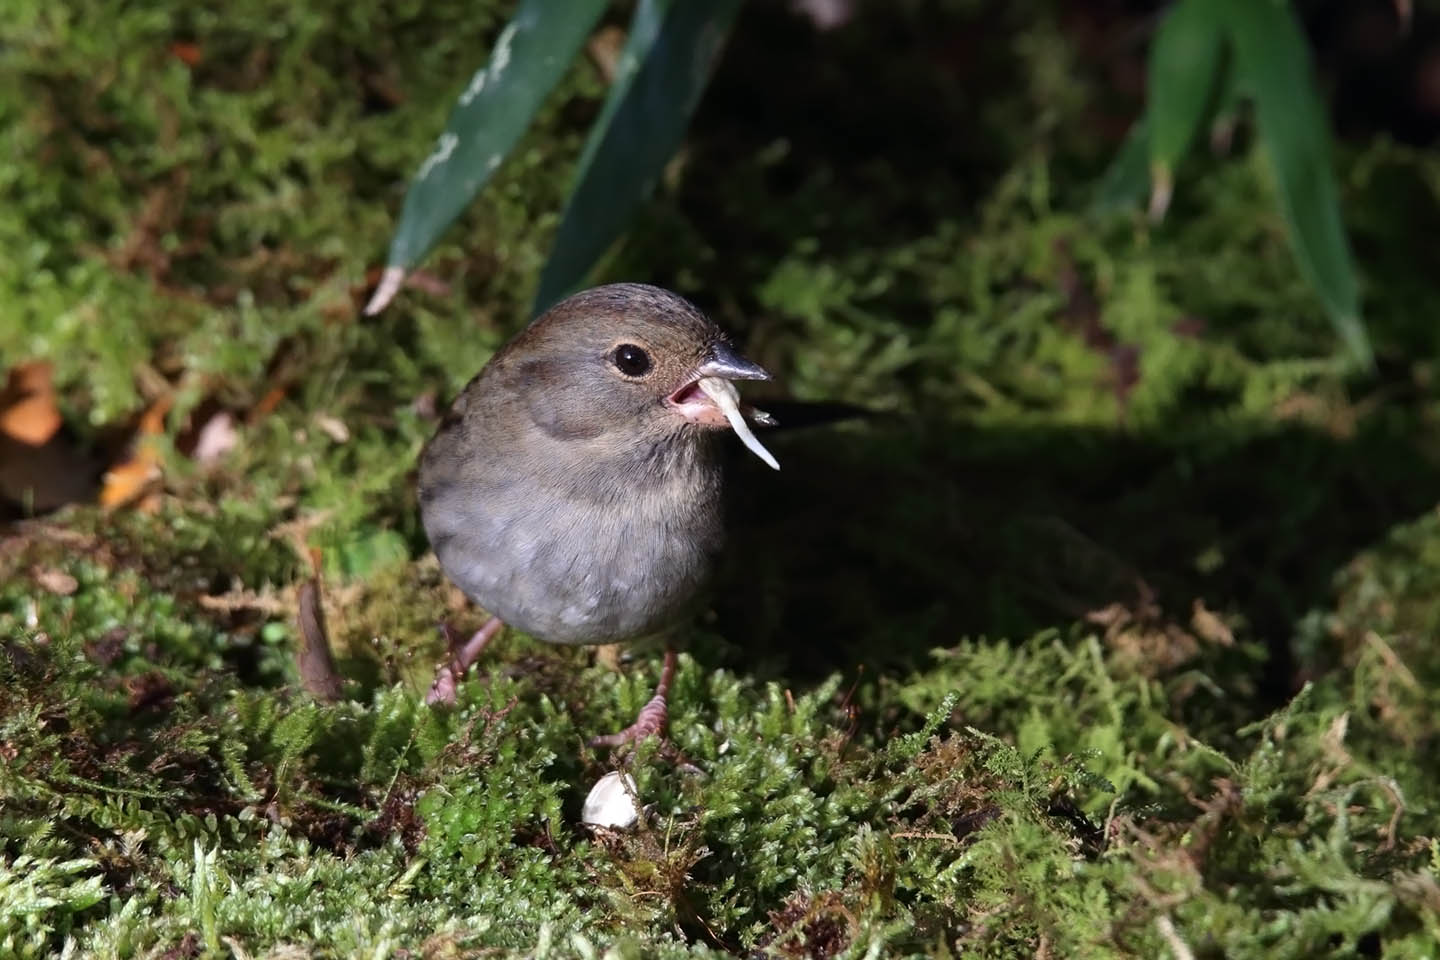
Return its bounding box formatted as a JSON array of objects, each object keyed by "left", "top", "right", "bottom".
[{"left": 419, "top": 284, "right": 779, "bottom": 746}]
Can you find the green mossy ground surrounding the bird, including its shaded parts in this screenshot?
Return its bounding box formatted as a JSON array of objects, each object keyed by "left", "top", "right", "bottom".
[{"left": 0, "top": 0, "right": 1440, "bottom": 957}]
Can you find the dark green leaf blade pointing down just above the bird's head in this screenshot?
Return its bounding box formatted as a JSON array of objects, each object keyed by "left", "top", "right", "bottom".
[{"left": 534, "top": 0, "right": 740, "bottom": 314}]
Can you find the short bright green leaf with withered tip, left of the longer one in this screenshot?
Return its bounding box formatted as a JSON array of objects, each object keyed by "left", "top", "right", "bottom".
[{"left": 1146, "top": 0, "right": 1224, "bottom": 220}]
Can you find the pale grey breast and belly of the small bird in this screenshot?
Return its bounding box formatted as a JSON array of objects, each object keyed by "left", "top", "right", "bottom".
[{"left": 422, "top": 443, "right": 723, "bottom": 643}]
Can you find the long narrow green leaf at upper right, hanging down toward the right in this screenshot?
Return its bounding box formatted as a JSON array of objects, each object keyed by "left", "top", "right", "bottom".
[{"left": 1223, "top": 0, "right": 1374, "bottom": 370}]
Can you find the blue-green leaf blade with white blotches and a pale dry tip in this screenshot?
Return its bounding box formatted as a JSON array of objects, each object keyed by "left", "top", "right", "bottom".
[{"left": 366, "top": 0, "right": 606, "bottom": 314}]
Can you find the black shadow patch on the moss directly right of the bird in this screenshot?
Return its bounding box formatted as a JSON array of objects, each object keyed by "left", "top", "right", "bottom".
[{"left": 716, "top": 419, "right": 1440, "bottom": 704}]
